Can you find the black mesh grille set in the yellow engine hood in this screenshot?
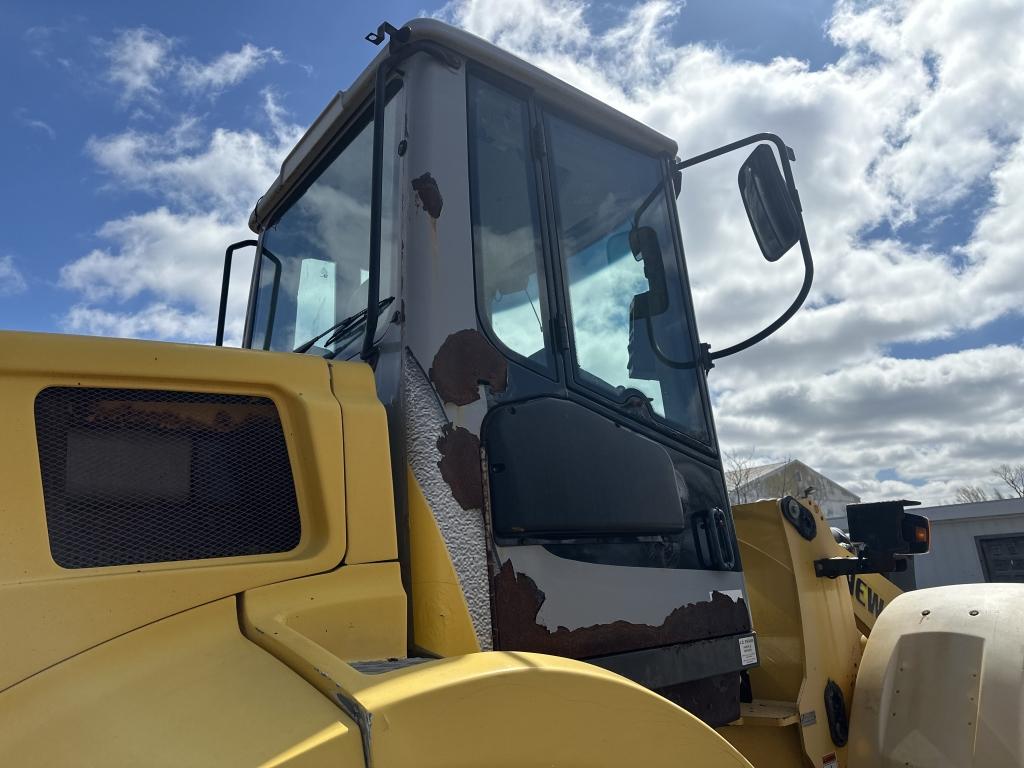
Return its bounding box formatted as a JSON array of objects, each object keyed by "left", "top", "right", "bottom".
[{"left": 36, "top": 387, "right": 301, "bottom": 568}]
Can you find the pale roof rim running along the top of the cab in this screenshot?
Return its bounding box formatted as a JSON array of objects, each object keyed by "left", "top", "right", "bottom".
[{"left": 249, "top": 18, "right": 678, "bottom": 233}]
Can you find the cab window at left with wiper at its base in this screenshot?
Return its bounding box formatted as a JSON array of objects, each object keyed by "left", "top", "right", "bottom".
[{"left": 251, "top": 87, "right": 397, "bottom": 357}]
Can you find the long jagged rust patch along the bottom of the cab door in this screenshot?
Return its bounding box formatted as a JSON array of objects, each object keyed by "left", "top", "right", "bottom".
[{"left": 495, "top": 560, "right": 751, "bottom": 658}]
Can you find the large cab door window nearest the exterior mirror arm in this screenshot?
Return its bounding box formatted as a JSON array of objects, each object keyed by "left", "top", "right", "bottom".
[{"left": 545, "top": 115, "right": 710, "bottom": 442}]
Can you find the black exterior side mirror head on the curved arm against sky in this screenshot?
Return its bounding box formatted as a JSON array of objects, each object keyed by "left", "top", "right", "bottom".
[{"left": 739, "top": 144, "right": 803, "bottom": 261}]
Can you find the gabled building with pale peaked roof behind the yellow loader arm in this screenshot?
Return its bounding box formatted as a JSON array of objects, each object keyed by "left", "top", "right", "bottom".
[{"left": 725, "top": 459, "right": 860, "bottom": 529}]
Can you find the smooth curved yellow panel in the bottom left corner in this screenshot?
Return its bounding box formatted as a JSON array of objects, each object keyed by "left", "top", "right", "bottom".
[{"left": 0, "top": 598, "right": 364, "bottom": 768}]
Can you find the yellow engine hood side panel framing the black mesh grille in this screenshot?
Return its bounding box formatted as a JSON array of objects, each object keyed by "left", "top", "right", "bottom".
[{"left": 0, "top": 333, "right": 352, "bottom": 690}]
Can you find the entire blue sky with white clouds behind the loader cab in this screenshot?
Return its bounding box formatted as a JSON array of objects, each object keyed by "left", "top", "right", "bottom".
[{"left": 0, "top": 0, "right": 1024, "bottom": 501}]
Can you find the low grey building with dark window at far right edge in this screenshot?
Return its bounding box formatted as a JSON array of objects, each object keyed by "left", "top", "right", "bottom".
[{"left": 910, "top": 499, "right": 1024, "bottom": 589}]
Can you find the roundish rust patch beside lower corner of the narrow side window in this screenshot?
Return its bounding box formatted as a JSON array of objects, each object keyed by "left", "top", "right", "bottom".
[{"left": 430, "top": 328, "right": 508, "bottom": 406}]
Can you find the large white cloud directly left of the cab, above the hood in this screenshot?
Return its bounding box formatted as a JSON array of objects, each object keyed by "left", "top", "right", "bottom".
[{"left": 59, "top": 93, "right": 301, "bottom": 343}]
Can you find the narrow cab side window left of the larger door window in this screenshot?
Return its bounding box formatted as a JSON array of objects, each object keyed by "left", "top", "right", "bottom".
[{"left": 468, "top": 77, "right": 552, "bottom": 368}]
